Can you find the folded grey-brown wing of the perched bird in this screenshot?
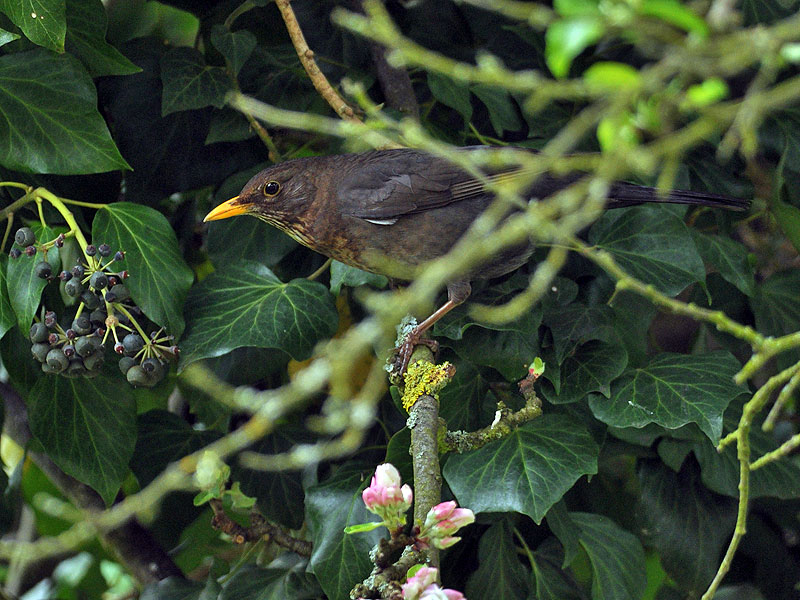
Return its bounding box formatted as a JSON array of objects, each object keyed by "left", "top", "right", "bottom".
[{"left": 337, "top": 150, "right": 512, "bottom": 225}]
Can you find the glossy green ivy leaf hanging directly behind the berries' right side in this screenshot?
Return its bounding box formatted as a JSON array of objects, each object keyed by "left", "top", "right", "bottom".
[{"left": 92, "top": 202, "right": 194, "bottom": 338}]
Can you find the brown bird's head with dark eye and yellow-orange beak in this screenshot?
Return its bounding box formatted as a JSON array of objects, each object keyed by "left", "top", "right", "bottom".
[{"left": 203, "top": 159, "right": 316, "bottom": 237}]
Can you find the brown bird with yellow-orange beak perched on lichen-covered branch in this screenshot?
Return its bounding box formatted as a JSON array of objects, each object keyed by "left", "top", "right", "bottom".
[{"left": 204, "top": 149, "right": 749, "bottom": 373}]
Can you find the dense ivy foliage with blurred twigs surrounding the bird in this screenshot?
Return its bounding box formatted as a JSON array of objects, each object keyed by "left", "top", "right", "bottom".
[{"left": 0, "top": 0, "right": 800, "bottom": 600}]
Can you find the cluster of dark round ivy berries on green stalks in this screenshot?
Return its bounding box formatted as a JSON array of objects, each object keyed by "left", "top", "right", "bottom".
[{"left": 10, "top": 227, "right": 178, "bottom": 387}]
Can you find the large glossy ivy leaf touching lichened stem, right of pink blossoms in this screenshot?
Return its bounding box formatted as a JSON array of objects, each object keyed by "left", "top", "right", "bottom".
[{"left": 443, "top": 414, "right": 599, "bottom": 523}]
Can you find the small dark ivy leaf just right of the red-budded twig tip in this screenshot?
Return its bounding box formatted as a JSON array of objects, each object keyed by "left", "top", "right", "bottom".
[{"left": 543, "top": 340, "right": 628, "bottom": 404}]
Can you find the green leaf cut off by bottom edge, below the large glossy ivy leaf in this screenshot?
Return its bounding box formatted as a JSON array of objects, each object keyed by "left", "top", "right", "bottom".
[{"left": 570, "top": 512, "right": 647, "bottom": 600}]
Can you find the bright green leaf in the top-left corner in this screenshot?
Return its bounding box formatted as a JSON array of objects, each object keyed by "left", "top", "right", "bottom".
[{"left": 0, "top": 0, "right": 67, "bottom": 51}]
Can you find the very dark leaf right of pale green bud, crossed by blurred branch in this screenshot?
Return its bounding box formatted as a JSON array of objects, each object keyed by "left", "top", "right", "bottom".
[{"left": 231, "top": 426, "right": 308, "bottom": 529}]
